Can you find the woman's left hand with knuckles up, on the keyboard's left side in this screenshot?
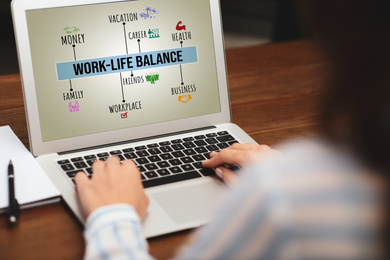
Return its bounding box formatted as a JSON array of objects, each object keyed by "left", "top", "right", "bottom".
[{"left": 75, "top": 156, "right": 149, "bottom": 219}]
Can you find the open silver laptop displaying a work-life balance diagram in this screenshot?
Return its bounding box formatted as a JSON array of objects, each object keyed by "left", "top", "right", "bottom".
[{"left": 12, "top": 0, "right": 255, "bottom": 237}]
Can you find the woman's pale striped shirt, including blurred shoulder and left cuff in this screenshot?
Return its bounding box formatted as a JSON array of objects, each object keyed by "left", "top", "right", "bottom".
[{"left": 85, "top": 141, "right": 381, "bottom": 260}]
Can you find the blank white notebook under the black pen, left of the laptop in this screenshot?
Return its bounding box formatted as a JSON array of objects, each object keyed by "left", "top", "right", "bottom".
[{"left": 0, "top": 126, "right": 60, "bottom": 212}]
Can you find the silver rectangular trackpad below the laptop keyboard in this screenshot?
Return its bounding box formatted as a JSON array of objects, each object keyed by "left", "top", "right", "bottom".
[{"left": 152, "top": 181, "right": 224, "bottom": 224}]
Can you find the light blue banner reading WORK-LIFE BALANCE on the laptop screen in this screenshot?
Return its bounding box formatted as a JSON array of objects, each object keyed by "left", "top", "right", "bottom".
[{"left": 56, "top": 46, "right": 198, "bottom": 80}]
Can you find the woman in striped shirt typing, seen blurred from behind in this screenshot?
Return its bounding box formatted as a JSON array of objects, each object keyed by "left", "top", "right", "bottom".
[{"left": 76, "top": 0, "right": 390, "bottom": 259}]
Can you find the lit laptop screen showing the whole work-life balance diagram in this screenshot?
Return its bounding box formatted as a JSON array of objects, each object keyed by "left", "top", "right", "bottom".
[{"left": 26, "top": 0, "right": 221, "bottom": 142}]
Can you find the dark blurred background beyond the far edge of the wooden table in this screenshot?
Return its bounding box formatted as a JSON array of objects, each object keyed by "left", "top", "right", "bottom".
[{"left": 0, "top": 0, "right": 303, "bottom": 75}]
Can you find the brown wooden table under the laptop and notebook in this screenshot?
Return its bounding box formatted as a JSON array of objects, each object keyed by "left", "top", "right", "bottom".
[{"left": 0, "top": 40, "right": 329, "bottom": 260}]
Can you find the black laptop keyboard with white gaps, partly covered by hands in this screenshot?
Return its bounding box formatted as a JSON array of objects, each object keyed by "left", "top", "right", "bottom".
[{"left": 57, "top": 131, "right": 237, "bottom": 188}]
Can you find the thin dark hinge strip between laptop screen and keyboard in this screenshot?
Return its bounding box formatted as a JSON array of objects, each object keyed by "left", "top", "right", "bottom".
[{"left": 57, "top": 126, "right": 217, "bottom": 155}]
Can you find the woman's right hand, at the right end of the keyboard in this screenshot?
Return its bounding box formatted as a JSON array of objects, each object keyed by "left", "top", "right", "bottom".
[{"left": 203, "top": 143, "right": 279, "bottom": 185}]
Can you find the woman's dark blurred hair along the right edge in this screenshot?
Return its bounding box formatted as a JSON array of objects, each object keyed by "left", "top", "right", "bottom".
[{"left": 301, "top": 0, "right": 390, "bottom": 259}]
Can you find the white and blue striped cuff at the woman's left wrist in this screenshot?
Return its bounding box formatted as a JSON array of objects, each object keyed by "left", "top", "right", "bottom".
[{"left": 84, "top": 204, "right": 153, "bottom": 259}]
